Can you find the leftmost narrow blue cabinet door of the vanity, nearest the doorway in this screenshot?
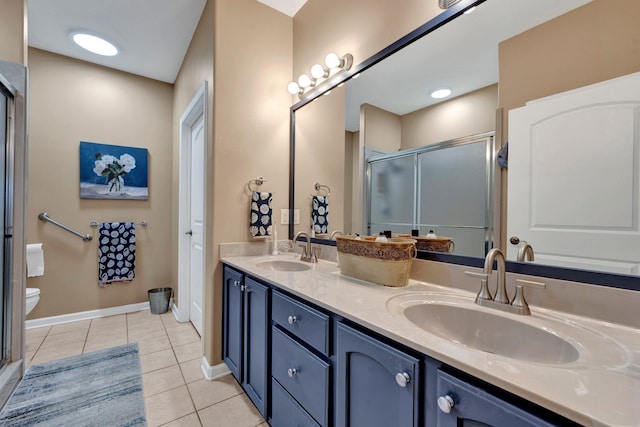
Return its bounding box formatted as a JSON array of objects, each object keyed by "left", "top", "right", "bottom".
[{"left": 222, "top": 266, "right": 244, "bottom": 383}]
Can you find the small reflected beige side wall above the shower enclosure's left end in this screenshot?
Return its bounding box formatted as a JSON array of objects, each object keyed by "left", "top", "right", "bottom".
[{"left": 360, "top": 104, "right": 402, "bottom": 153}]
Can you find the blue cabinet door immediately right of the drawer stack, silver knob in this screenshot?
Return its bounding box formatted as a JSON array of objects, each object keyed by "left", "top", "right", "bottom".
[{"left": 336, "top": 324, "right": 420, "bottom": 427}]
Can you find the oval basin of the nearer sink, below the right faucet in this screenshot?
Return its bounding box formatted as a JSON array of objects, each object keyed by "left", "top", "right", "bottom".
[{"left": 404, "top": 304, "right": 580, "bottom": 364}]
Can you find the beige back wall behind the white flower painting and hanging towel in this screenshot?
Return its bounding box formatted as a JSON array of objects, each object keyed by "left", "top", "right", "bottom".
[{"left": 27, "top": 49, "right": 173, "bottom": 318}]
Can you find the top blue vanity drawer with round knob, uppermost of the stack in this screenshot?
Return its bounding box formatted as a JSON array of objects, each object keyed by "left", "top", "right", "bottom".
[{"left": 271, "top": 291, "right": 331, "bottom": 356}]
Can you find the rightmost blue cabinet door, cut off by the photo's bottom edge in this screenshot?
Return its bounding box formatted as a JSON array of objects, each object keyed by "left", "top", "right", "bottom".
[{"left": 437, "top": 371, "right": 556, "bottom": 427}]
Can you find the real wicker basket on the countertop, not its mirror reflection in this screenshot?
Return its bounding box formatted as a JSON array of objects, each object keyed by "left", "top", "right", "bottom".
[{"left": 336, "top": 236, "right": 417, "bottom": 287}]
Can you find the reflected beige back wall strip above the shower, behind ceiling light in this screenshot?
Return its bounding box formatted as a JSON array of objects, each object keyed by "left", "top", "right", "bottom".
[{"left": 402, "top": 84, "right": 498, "bottom": 150}]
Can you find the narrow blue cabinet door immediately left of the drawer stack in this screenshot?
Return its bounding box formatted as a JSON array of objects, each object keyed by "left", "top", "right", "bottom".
[{"left": 242, "top": 278, "right": 269, "bottom": 416}]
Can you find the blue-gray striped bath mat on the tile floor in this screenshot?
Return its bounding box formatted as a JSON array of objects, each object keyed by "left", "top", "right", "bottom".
[{"left": 0, "top": 343, "right": 146, "bottom": 427}]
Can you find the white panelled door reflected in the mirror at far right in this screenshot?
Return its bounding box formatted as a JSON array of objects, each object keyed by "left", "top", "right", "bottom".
[{"left": 507, "top": 73, "right": 640, "bottom": 275}]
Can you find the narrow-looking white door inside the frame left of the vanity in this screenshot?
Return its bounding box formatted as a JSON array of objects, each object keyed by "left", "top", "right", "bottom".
[{"left": 189, "top": 115, "right": 205, "bottom": 335}]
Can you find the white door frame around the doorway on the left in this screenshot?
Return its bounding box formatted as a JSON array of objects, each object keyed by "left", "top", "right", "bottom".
[{"left": 177, "top": 81, "right": 208, "bottom": 326}]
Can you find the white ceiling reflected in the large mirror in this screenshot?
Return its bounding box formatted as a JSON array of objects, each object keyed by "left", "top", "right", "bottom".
[{"left": 345, "top": 0, "right": 591, "bottom": 131}]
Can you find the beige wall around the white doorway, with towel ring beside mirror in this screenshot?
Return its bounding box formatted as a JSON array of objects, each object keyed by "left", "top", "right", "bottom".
[{"left": 172, "top": 0, "right": 292, "bottom": 365}]
